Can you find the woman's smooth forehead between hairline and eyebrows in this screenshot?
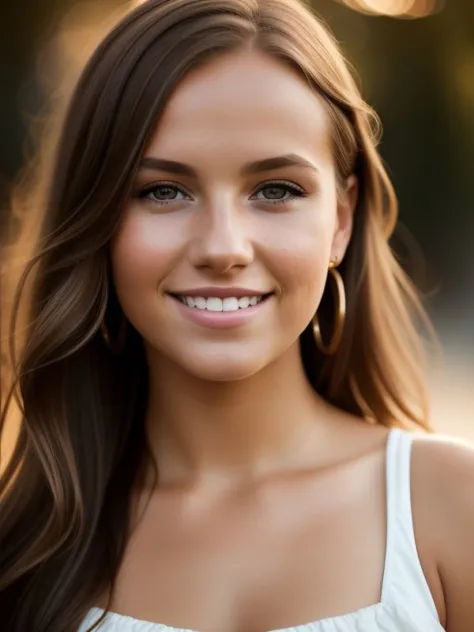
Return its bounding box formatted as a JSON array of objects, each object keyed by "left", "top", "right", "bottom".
[{"left": 145, "top": 52, "right": 332, "bottom": 168}]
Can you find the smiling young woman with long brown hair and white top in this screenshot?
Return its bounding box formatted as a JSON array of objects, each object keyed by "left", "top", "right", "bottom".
[{"left": 0, "top": 0, "right": 474, "bottom": 632}]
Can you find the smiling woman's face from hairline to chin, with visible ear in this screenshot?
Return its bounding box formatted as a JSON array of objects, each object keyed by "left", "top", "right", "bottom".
[{"left": 112, "top": 52, "right": 356, "bottom": 381}]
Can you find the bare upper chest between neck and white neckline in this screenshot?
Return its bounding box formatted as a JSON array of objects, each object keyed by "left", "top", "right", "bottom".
[{"left": 107, "top": 452, "right": 386, "bottom": 632}]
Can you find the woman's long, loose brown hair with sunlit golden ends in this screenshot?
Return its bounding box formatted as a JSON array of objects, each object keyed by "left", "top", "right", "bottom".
[{"left": 0, "top": 0, "right": 436, "bottom": 632}]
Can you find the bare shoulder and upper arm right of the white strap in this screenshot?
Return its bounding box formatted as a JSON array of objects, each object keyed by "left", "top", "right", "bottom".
[{"left": 411, "top": 435, "right": 474, "bottom": 632}]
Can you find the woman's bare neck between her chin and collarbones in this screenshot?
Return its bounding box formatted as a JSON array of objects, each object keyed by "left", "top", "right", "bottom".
[{"left": 146, "top": 344, "right": 330, "bottom": 483}]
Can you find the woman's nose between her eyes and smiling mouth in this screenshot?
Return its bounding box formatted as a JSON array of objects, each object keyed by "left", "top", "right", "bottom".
[{"left": 190, "top": 199, "right": 254, "bottom": 274}]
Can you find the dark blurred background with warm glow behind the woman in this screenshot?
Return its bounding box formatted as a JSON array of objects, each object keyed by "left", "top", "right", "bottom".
[{"left": 0, "top": 0, "right": 474, "bottom": 440}]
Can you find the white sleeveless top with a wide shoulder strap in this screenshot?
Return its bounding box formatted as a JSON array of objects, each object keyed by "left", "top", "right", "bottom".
[{"left": 78, "top": 428, "right": 444, "bottom": 632}]
